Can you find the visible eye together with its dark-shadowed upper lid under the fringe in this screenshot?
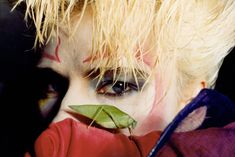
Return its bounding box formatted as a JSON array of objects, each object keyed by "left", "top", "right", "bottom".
[{"left": 86, "top": 68, "right": 147, "bottom": 96}]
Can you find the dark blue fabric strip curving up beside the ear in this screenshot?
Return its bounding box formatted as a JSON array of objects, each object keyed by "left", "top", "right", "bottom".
[{"left": 148, "top": 89, "right": 235, "bottom": 157}]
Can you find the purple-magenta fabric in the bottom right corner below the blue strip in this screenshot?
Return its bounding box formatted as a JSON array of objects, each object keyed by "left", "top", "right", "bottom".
[{"left": 157, "top": 122, "right": 235, "bottom": 157}]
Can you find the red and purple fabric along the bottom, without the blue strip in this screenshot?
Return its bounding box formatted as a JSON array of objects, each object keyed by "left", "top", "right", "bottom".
[{"left": 35, "top": 119, "right": 235, "bottom": 157}]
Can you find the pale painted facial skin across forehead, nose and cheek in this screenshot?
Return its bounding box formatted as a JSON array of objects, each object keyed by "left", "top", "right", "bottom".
[{"left": 38, "top": 9, "right": 205, "bottom": 135}]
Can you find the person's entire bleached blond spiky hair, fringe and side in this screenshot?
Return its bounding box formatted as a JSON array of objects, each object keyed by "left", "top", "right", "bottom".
[{"left": 12, "top": 0, "right": 235, "bottom": 105}]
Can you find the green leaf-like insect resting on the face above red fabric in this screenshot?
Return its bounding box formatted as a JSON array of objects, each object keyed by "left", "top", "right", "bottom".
[{"left": 69, "top": 104, "right": 137, "bottom": 132}]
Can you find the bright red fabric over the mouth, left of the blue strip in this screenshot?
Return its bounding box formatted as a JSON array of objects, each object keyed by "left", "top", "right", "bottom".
[{"left": 35, "top": 119, "right": 160, "bottom": 157}]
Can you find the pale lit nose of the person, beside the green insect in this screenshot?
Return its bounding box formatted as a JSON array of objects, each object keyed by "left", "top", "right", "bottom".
[{"left": 53, "top": 78, "right": 97, "bottom": 122}]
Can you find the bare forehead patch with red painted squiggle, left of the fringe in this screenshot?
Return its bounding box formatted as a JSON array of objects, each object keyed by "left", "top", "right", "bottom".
[{"left": 38, "top": 11, "right": 92, "bottom": 75}]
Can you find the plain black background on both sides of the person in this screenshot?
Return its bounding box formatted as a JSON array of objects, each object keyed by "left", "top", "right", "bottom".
[{"left": 0, "top": 0, "right": 235, "bottom": 156}]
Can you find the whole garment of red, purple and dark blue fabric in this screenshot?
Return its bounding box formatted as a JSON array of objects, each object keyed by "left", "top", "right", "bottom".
[{"left": 28, "top": 89, "right": 235, "bottom": 157}]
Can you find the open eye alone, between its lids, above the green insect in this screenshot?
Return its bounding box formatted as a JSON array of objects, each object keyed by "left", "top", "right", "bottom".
[{"left": 97, "top": 80, "right": 138, "bottom": 96}]
